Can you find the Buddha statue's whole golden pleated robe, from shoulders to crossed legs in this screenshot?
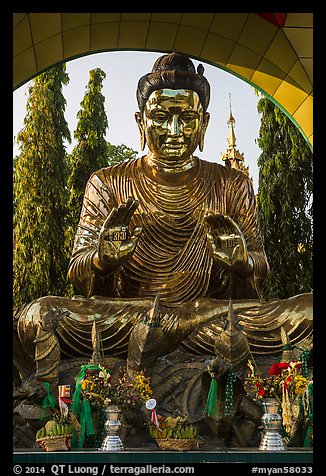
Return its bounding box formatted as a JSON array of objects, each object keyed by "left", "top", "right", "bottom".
[{"left": 15, "top": 159, "right": 312, "bottom": 378}]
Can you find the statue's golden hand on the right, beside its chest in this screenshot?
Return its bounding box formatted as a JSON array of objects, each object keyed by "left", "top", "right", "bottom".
[{"left": 205, "top": 213, "right": 253, "bottom": 277}]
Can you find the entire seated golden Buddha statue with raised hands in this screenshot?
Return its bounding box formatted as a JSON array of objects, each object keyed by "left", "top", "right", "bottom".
[{"left": 14, "top": 52, "right": 312, "bottom": 381}]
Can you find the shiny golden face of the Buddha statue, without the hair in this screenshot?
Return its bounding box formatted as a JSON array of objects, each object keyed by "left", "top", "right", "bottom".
[{"left": 138, "top": 89, "right": 208, "bottom": 162}]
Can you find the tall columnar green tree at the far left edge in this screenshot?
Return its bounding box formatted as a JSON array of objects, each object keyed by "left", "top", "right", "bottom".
[{"left": 13, "top": 65, "right": 70, "bottom": 307}]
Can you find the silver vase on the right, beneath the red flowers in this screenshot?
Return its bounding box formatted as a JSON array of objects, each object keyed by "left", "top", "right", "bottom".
[{"left": 259, "top": 398, "right": 285, "bottom": 451}]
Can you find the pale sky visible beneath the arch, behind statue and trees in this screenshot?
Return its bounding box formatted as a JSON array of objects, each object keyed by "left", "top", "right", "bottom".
[{"left": 13, "top": 51, "right": 261, "bottom": 193}]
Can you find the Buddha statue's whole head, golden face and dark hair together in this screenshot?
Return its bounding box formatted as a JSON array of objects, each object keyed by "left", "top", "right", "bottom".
[{"left": 135, "top": 52, "right": 210, "bottom": 169}]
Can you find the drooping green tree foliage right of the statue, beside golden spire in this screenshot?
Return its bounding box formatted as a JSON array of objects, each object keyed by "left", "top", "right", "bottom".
[{"left": 257, "top": 98, "right": 313, "bottom": 299}]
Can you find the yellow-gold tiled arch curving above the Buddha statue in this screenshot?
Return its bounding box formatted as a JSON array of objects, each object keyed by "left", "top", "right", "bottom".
[{"left": 13, "top": 13, "right": 313, "bottom": 144}]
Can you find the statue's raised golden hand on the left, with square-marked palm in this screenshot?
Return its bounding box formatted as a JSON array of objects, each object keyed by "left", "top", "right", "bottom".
[{"left": 93, "top": 197, "right": 142, "bottom": 274}]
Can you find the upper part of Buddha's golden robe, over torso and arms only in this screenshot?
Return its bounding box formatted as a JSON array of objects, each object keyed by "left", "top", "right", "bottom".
[{"left": 69, "top": 159, "right": 268, "bottom": 306}]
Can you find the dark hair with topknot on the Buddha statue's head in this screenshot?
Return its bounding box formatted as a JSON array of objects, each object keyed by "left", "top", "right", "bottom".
[{"left": 136, "top": 51, "right": 210, "bottom": 112}]
